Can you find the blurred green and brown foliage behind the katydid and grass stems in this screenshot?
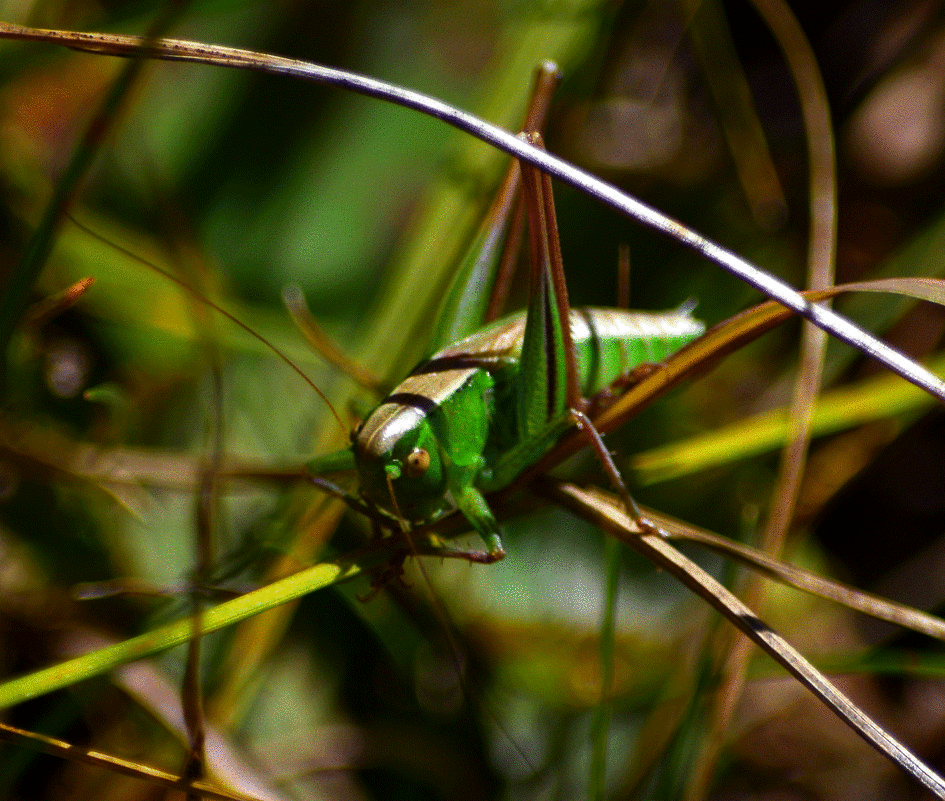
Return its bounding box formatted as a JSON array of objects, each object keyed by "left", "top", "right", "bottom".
[{"left": 0, "top": 0, "right": 945, "bottom": 799}]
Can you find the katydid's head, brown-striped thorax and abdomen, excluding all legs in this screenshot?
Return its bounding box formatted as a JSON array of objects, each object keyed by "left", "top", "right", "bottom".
[{"left": 354, "top": 309, "right": 704, "bottom": 521}]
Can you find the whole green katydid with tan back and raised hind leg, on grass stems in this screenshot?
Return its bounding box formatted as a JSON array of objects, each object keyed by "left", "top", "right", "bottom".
[{"left": 308, "top": 123, "right": 704, "bottom": 562}]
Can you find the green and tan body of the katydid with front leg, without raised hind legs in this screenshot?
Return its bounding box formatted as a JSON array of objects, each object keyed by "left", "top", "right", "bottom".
[{"left": 340, "top": 309, "right": 703, "bottom": 553}]
